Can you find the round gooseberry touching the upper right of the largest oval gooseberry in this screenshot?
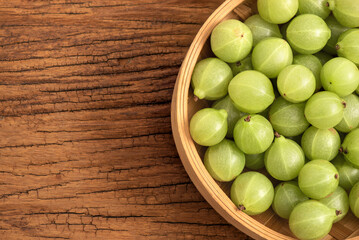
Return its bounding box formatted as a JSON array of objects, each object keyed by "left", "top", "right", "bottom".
[{"left": 252, "top": 37, "right": 293, "bottom": 78}]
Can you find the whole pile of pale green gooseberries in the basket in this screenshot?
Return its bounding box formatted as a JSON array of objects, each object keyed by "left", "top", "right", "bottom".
[{"left": 190, "top": 0, "right": 359, "bottom": 239}]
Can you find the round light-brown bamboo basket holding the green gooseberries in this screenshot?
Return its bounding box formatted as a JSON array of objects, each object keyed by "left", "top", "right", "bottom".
[{"left": 171, "top": 0, "right": 359, "bottom": 240}]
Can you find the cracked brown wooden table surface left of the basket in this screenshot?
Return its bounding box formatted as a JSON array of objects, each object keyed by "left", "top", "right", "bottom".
[{"left": 0, "top": 0, "right": 252, "bottom": 240}]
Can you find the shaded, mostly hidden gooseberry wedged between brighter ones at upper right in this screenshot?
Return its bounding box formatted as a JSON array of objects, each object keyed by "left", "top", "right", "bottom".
[{"left": 323, "top": 15, "right": 350, "bottom": 55}]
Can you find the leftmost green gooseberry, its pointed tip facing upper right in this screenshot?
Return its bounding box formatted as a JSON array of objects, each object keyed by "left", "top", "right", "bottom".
[{"left": 189, "top": 108, "right": 228, "bottom": 146}]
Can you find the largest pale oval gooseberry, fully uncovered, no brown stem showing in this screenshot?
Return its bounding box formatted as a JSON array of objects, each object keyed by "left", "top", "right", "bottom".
[{"left": 228, "top": 70, "right": 274, "bottom": 113}]
